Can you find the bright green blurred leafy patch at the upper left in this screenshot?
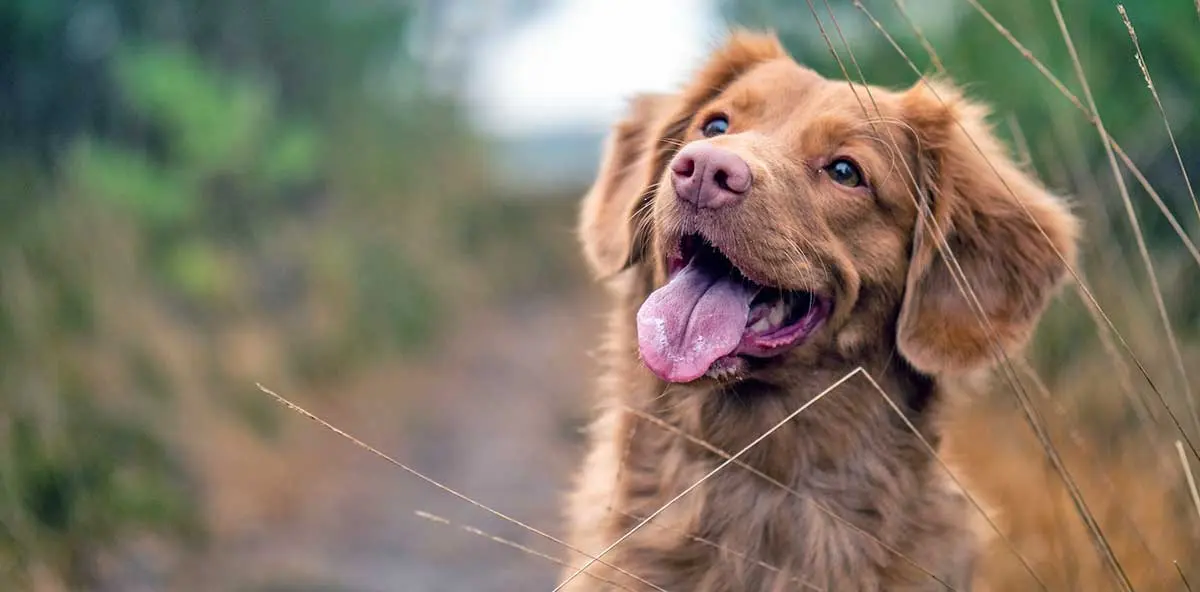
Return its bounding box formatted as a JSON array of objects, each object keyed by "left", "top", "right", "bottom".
[{"left": 70, "top": 48, "right": 320, "bottom": 304}]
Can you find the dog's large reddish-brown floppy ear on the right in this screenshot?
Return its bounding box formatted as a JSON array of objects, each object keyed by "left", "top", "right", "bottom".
[{"left": 896, "top": 82, "right": 1079, "bottom": 375}]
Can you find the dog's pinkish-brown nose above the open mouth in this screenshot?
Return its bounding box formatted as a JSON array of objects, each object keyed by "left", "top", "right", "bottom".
[{"left": 671, "top": 143, "right": 752, "bottom": 210}]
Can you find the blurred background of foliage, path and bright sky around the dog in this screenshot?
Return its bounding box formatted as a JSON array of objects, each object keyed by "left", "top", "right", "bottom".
[{"left": 0, "top": 0, "right": 1200, "bottom": 591}]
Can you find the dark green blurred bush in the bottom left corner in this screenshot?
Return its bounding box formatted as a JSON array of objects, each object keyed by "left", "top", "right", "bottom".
[{"left": 0, "top": 401, "right": 199, "bottom": 587}]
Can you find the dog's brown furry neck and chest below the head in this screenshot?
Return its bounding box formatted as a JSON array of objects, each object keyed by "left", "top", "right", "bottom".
[{"left": 561, "top": 270, "right": 971, "bottom": 591}]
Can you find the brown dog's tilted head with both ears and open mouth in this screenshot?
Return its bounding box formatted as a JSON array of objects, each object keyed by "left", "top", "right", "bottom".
[{"left": 581, "top": 32, "right": 1078, "bottom": 382}]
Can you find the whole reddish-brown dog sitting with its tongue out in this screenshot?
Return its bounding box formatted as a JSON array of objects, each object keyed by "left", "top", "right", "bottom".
[{"left": 565, "top": 32, "right": 1078, "bottom": 592}]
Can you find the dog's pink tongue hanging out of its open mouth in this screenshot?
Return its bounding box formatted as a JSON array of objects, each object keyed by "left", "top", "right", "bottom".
[{"left": 637, "top": 259, "right": 754, "bottom": 382}]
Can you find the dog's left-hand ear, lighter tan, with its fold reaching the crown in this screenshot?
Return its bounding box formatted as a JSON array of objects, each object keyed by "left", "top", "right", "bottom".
[{"left": 580, "top": 31, "right": 787, "bottom": 277}]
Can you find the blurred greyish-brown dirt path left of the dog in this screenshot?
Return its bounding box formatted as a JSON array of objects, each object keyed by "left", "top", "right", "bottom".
[{"left": 200, "top": 290, "right": 599, "bottom": 592}]
